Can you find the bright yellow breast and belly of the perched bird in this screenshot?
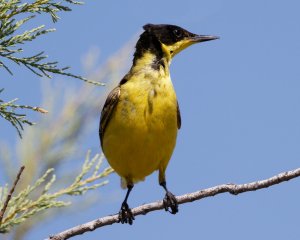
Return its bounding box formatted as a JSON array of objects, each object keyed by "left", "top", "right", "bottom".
[{"left": 103, "top": 74, "right": 177, "bottom": 187}]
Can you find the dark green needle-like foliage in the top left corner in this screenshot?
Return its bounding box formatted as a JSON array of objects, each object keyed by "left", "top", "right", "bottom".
[{"left": 0, "top": 0, "right": 88, "bottom": 81}]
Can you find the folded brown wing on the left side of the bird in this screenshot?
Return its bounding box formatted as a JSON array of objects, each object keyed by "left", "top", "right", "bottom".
[{"left": 99, "top": 86, "right": 121, "bottom": 147}]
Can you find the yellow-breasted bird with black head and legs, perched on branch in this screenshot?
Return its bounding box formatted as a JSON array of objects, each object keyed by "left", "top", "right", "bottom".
[{"left": 99, "top": 24, "right": 219, "bottom": 225}]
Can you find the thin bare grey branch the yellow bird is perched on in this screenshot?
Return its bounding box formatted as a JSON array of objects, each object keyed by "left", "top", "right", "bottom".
[{"left": 48, "top": 168, "right": 300, "bottom": 240}]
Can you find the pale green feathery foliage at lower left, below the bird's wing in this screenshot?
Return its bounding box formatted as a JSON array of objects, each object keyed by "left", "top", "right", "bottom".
[{"left": 0, "top": 151, "right": 113, "bottom": 233}]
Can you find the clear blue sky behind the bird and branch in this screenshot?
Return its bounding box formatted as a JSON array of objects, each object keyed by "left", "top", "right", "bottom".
[{"left": 0, "top": 0, "right": 300, "bottom": 240}]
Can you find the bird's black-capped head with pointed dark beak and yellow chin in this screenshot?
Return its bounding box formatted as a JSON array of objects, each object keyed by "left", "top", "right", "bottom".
[{"left": 134, "top": 24, "right": 218, "bottom": 64}]
